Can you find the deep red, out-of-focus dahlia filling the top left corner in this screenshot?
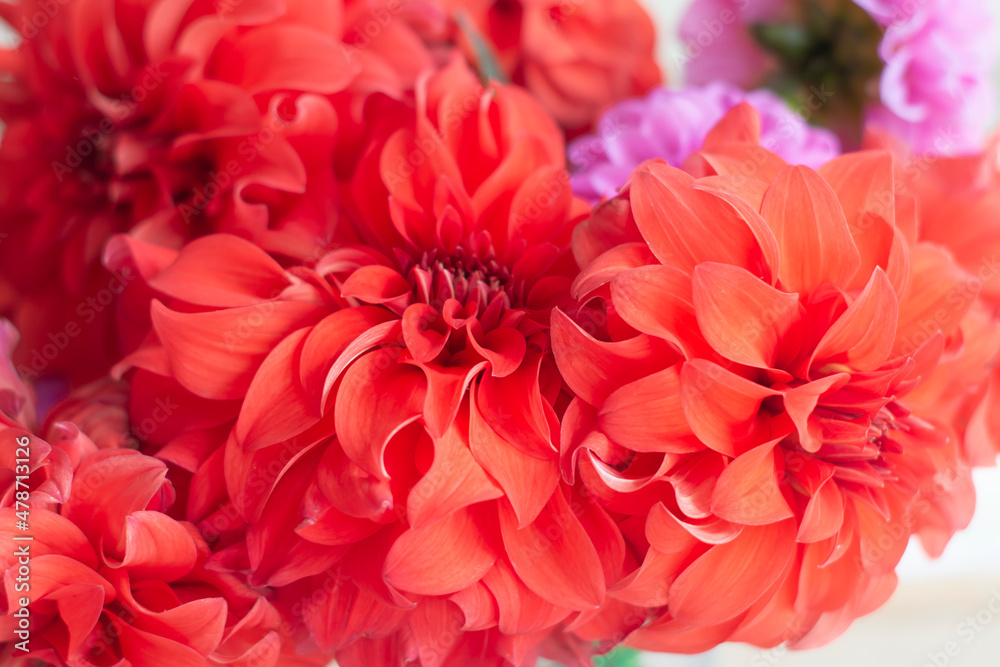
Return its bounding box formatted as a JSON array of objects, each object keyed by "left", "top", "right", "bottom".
[{"left": 0, "top": 0, "right": 373, "bottom": 384}]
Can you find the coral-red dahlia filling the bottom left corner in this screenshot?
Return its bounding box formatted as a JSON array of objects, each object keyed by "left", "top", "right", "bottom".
[{"left": 0, "top": 320, "right": 310, "bottom": 667}]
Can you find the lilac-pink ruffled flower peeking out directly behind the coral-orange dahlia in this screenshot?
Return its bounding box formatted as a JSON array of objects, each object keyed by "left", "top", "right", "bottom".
[{"left": 569, "top": 82, "right": 840, "bottom": 201}]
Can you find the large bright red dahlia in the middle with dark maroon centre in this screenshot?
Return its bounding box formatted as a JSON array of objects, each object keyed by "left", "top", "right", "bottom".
[{"left": 121, "top": 62, "right": 624, "bottom": 667}]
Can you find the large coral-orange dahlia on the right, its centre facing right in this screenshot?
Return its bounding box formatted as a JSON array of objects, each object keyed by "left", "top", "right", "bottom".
[{"left": 552, "top": 106, "right": 995, "bottom": 652}]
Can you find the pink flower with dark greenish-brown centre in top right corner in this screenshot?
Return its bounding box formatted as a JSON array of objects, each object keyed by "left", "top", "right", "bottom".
[{"left": 681, "top": 0, "right": 996, "bottom": 154}]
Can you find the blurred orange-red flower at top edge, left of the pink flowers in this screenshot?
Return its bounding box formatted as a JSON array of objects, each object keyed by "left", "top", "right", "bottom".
[{"left": 441, "top": 0, "right": 660, "bottom": 135}]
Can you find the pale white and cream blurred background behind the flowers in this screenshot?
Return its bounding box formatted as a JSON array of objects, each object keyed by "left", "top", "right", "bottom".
[{"left": 612, "top": 0, "right": 1000, "bottom": 667}]
